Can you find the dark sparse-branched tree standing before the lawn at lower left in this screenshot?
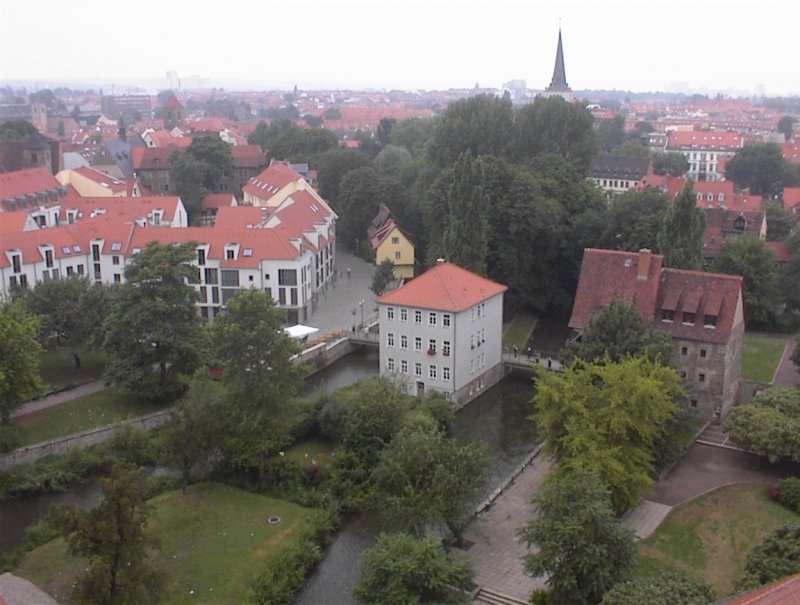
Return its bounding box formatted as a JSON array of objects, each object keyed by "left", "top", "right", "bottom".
[{"left": 55, "top": 466, "right": 163, "bottom": 605}]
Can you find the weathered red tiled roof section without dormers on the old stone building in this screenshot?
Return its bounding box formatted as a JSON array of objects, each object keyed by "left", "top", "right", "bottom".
[{"left": 569, "top": 248, "right": 664, "bottom": 329}]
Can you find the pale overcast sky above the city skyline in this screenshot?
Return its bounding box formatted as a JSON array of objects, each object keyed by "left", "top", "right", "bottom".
[{"left": 0, "top": 0, "right": 800, "bottom": 95}]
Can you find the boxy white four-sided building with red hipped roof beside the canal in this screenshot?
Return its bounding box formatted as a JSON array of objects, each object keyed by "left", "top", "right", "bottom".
[{"left": 377, "top": 260, "right": 507, "bottom": 406}]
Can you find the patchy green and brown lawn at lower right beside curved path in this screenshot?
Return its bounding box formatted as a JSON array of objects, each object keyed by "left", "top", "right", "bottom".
[{"left": 638, "top": 484, "right": 800, "bottom": 599}]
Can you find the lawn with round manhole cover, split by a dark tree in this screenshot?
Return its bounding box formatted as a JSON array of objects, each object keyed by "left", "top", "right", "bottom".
[{"left": 15, "top": 483, "right": 319, "bottom": 605}]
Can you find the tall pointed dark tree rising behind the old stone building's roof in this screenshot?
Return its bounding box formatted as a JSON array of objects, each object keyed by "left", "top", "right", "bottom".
[{"left": 658, "top": 179, "right": 706, "bottom": 270}]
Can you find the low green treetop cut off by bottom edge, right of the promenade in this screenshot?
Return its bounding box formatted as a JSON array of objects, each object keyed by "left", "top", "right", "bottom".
[{"left": 600, "top": 572, "right": 714, "bottom": 605}]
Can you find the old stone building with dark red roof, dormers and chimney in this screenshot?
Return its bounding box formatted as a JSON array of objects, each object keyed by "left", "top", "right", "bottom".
[{"left": 569, "top": 248, "right": 744, "bottom": 418}]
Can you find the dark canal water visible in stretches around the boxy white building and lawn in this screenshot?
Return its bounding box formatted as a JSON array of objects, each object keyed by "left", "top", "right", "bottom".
[{"left": 0, "top": 347, "right": 537, "bottom": 605}]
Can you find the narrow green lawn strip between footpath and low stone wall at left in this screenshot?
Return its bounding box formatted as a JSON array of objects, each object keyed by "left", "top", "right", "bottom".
[{"left": 11, "top": 388, "right": 164, "bottom": 447}]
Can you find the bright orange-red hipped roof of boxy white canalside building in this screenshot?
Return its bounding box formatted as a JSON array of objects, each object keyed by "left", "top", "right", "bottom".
[{"left": 377, "top": 262, "right": 508, "bottom": 313}]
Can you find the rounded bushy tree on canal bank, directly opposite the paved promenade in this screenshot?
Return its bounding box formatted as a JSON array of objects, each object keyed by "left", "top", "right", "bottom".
[{"left": 372, "top": 423, "right": 487, "bottom": 543}]
